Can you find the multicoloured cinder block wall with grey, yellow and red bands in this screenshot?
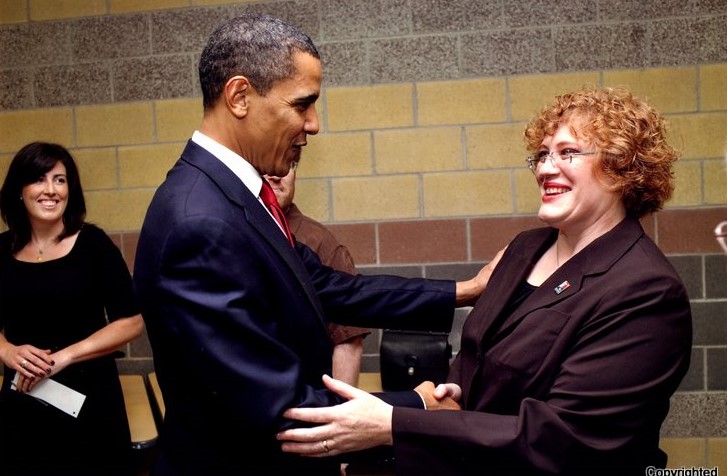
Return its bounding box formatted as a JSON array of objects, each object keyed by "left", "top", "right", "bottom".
[{"left": 0, "top": 0, "right": 727, "bottom": 471}]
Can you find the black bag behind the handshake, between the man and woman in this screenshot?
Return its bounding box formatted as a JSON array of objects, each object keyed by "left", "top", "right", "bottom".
[{"left": 379, "top": 329, "right": 452, "bottom": 391}]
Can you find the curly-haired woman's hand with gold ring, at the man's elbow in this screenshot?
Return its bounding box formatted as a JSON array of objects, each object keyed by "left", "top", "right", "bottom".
[{"left": 277, "top": 375, "right": 393, "bottom": 457}]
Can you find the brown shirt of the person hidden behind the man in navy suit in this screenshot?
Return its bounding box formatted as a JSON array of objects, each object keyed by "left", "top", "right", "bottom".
[{"left": 285, "top": 203, "right": 371, "bottom": 345}]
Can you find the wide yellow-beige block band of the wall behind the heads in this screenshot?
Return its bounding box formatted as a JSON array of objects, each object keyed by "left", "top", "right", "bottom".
[{"left": 0, "top": 64, "right": 727, "bottom": 232}]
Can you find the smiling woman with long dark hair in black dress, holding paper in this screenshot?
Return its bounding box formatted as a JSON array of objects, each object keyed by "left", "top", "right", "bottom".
[{"left": 0, "top": 142, "right": 143, "bottom": 476}]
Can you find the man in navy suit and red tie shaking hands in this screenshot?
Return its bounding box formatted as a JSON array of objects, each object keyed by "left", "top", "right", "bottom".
[{"left": 134, "top": 14, "right": 489, "bottom": 476}]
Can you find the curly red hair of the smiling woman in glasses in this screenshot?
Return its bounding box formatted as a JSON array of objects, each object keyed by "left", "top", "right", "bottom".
[{"left": 524, "top": 88, "right": 679, "bottom": 218}]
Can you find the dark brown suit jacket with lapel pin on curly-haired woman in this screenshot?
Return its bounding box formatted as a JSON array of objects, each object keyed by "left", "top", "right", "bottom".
[{"left": 393, "top": 218, "right": 692, "bottom": 476}]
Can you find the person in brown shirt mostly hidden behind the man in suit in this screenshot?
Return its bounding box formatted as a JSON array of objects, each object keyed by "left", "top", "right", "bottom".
[{"left": 263, "top": 162, "right": 370, "bottom": 387}]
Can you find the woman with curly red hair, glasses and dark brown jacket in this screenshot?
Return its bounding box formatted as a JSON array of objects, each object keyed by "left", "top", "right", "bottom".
[{"left": 279, "top": 89, "right": 692, "bottom": 476}]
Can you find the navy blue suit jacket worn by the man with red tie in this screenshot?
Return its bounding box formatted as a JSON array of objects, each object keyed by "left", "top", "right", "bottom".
[{"left": 134, "top": 141, "right": 454, "bottom": 476}]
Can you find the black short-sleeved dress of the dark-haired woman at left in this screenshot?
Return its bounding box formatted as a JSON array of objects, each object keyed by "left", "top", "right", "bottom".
[{"left": 0, "top": 224, "right": 139, "bottom": 475}]
